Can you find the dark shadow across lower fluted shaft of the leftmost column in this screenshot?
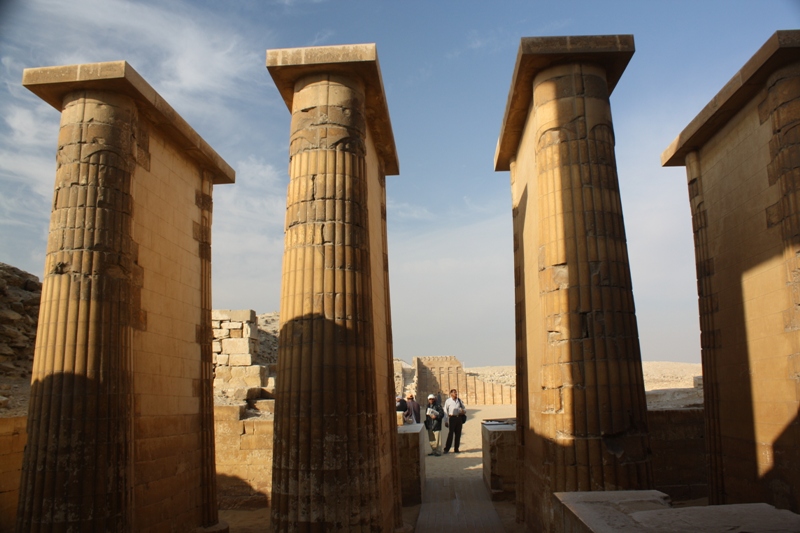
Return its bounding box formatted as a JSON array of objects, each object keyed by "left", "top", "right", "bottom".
[{"left": 17, "top": 373, "right": 130, "bottom": 531}]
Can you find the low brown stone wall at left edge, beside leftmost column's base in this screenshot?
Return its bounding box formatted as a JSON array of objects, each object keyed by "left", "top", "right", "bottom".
[{"left": 0, "top": 416, "right": 28, "bottom": 533}]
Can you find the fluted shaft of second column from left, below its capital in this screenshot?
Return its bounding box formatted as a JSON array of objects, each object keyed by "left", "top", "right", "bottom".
[{"left": 272, "top": 74, "right": 382, "bottom": 531}]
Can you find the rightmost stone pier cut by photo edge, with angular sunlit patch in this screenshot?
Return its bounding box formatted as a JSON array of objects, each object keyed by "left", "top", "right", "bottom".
[{"left": 662, "top": 30, "right": 800, "bottom": 512}]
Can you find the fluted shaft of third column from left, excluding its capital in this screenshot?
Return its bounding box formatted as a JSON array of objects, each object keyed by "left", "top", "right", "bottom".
[{"left": 526, "top": 63, "right": 652, "bottom": 520}]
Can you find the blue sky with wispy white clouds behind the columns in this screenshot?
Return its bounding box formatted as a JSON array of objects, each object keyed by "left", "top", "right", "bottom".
[{"left": 0, "top": 0, "right": 800, "bottom": 366}]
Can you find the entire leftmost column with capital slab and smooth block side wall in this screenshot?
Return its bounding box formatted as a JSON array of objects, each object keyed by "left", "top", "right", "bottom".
[{"left": 17, "top": 62, "right": 233, "bottom": 531}]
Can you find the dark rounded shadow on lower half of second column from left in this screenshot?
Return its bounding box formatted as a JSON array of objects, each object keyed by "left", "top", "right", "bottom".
[{"left": 272, "top": 310, "right": 396, "bottom": 531}]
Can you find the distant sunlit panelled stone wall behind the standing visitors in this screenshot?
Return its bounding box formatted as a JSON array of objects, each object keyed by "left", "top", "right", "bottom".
[{"left": 410, "top": 355, "right": 517, "bottom": 405}]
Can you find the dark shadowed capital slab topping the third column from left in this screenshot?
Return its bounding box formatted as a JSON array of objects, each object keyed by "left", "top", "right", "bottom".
[{"left": 494, "top": 35, "right": 634, "bottom": 171}]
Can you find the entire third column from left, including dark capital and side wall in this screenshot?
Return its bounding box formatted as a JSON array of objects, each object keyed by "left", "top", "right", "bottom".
[{"left": 495, "top": 35, "right": 652, "bottom": 530}]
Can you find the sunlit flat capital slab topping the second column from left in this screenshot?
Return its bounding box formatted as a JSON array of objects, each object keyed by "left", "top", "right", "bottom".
[{"left": 267, "top": 43, "right": 400, "bottom": 176}]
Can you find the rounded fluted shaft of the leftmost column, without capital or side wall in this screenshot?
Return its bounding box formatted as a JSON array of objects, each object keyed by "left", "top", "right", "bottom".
[{"left": 17, "top": 91, "right": 138, "bottom": 531}]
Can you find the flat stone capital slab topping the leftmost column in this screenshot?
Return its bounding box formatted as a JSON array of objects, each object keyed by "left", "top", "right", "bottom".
[{"left": 22, "top": 61, "right": 236, "bottom": 185}]
